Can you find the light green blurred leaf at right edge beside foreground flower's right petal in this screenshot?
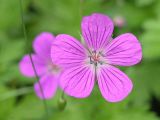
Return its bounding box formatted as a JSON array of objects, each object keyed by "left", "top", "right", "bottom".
[{"left": 139, "top": 19, "right": 160, "bottom": 59}]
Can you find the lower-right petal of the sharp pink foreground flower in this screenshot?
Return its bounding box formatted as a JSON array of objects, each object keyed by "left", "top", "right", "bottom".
[{"left": 97, "top": 66, "right": 133, "bottom": 102}]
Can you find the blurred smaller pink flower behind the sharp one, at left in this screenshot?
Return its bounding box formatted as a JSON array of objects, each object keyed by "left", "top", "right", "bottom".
[{"left": 19, "top": 32, "right": 60, "bottom": 99}]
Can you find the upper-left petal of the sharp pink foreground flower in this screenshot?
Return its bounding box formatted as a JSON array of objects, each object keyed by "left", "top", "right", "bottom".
[{"left": 51, "top": 34, "right": 86, "bottom": 68}]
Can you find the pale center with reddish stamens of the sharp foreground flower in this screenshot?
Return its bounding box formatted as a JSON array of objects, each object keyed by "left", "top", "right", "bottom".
[{"left": 89, "top": 51, "right": 104, "bottom": 66}]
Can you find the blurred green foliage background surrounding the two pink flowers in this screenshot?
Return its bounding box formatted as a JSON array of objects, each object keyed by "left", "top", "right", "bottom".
[{"left": 0, "top": 0, "right": 160, "bottom": 120}]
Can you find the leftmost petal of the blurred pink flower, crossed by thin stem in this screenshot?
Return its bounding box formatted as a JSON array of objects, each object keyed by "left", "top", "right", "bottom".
[{"left": 19, "top": 54, "right": 46, "bottom": 77}]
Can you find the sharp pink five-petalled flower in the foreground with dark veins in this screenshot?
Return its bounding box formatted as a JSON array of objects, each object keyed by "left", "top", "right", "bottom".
[{"left": 51, "top": 13, "right": 142, "bottom": 102}]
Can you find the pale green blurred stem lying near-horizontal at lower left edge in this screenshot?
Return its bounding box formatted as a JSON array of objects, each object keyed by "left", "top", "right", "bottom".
[{"left": 0, "top": 87, "right": 33, "bottom": 102}]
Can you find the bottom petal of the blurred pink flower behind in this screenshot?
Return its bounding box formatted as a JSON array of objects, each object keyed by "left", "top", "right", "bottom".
[{"left": 34, "top": 75, "right": 58, "bottom": 99}]
